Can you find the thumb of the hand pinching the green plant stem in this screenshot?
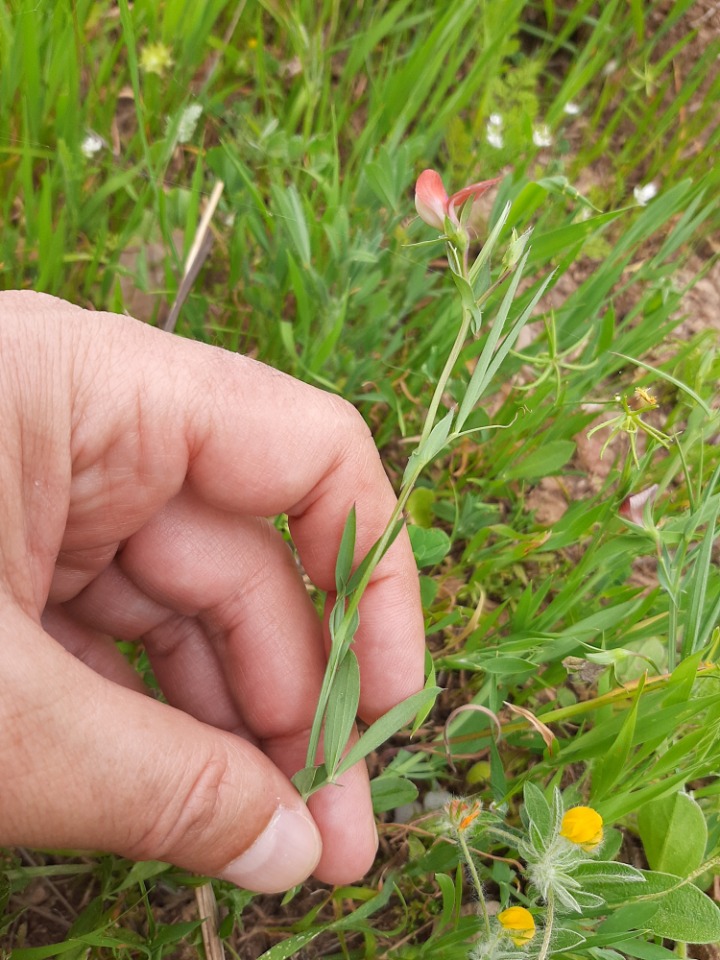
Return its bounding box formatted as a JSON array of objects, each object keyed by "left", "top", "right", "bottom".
[{"left": 0, "top": 607, "right": 321, "bottom": 893}]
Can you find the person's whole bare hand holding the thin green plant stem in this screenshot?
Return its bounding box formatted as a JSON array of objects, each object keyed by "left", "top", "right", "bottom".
[{"left": 0, "top": 292, "right": 423, "bottom": 892}]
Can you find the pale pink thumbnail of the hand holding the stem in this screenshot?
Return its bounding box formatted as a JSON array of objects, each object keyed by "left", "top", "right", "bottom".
[{"left": 220, "top": 807, "right": 322, "bottom": 893}]
